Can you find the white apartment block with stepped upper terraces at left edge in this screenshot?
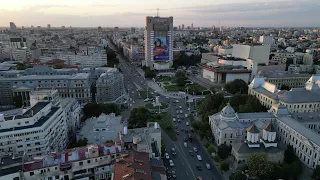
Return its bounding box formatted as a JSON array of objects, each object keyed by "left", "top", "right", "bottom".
[{"left": 0, "top": 102, "right": 68, "bottom": 158}]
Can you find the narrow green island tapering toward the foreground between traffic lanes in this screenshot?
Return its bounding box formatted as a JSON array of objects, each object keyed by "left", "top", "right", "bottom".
[{"left": 151, "top": 113, "right": 178, "bottom": 141}]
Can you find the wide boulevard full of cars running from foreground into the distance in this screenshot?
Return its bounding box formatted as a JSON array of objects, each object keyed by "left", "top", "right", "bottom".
[{"left": 109, "top": 40, "right": 223, "bottom": 180}]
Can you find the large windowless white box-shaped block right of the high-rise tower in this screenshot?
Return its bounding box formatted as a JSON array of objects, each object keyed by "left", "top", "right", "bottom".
[{"left": 232, "top": 44, "right": 270, "bottom": 65}]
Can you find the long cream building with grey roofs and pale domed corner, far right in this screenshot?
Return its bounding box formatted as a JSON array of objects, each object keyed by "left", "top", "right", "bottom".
[{"left": 248, "top": 75, "right": 320, "bottom": 113}]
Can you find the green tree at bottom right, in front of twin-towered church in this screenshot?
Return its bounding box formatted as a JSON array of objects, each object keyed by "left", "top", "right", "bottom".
[{"left": 247, "top": 153, "right": 275, "bottom": 179}]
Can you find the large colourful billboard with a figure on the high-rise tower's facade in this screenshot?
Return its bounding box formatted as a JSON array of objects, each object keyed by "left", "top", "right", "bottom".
[{"left": 153, "top": 36, "right": 169, "bottom": 61}]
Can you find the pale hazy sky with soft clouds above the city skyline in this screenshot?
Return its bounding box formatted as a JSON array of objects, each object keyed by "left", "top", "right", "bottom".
[{"left": 0, "top": 0, "right": 320, "bottom": 27}]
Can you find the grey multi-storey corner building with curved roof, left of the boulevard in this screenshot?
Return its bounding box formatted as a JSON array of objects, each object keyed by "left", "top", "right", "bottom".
[{"left": 96, "top": 68, "right": 127, "bottom": 104}]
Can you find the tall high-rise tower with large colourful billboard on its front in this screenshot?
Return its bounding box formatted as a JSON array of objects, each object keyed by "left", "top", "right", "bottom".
[{"left": 144, "top": 16, "right": 174, "bottom": 70}]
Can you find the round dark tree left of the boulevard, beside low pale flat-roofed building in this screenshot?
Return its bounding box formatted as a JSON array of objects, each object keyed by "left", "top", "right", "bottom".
[{"left": 128, "top": 106, "right": 152, "bottom": 128}]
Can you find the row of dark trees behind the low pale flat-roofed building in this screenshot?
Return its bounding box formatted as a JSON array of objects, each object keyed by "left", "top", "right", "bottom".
[{"left": 83, "top": 103, "right": 120, "bottom": 118}]
